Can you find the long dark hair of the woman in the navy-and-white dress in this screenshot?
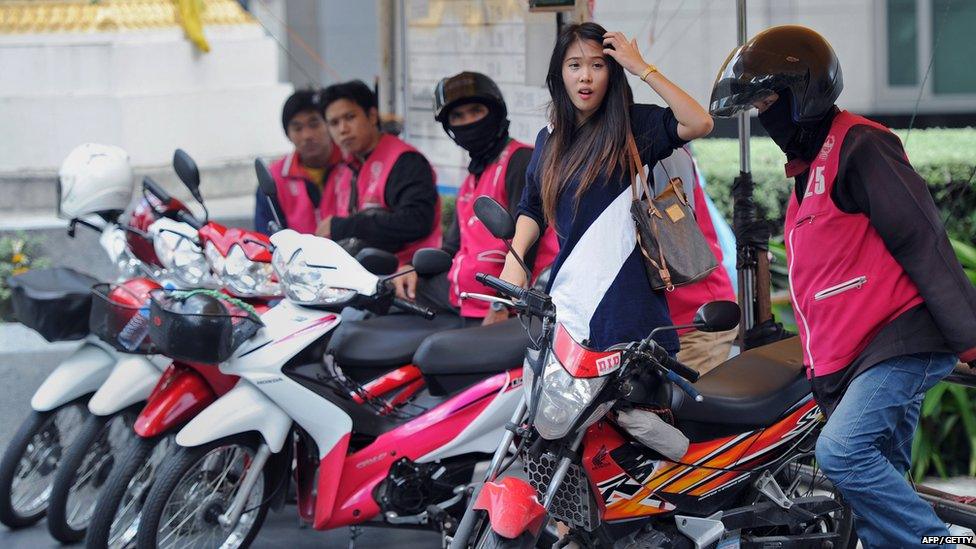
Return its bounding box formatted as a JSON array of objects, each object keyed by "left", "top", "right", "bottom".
[{"left": 541, "top": 22, "right": 634, "bottom": 224}]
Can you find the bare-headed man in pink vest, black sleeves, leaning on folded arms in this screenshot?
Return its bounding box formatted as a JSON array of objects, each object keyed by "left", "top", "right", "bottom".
[{"left": 315, "top": 80, "right": 441, "bottom": 264}]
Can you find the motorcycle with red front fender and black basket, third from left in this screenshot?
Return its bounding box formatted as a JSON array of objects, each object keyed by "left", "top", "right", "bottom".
[{"left": 85, "top": 150, "right": 280, "bottom": 548}]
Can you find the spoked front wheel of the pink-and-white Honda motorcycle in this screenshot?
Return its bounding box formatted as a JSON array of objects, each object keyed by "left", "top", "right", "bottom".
[{"left": 136, "top": 436, "right": 272, "bottom": 549}]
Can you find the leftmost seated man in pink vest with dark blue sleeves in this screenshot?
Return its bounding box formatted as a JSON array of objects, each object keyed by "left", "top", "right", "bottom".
[{"left": 254, "top": 90, "right": 341, "bottom": 233}]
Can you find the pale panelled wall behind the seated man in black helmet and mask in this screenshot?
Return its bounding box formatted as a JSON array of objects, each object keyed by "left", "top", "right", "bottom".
[{"left": 405, "top": 0, "right": 556, "bottom": 190}]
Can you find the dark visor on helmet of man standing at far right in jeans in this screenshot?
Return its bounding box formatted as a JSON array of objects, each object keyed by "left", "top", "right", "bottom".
[{"left": 708, "top": 46, "right": 792, "bottom": 118}]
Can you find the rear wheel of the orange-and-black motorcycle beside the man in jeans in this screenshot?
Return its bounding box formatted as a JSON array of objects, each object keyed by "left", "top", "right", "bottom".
[{"left": 742, "top": 452, "right": 857, "bottom": 549}]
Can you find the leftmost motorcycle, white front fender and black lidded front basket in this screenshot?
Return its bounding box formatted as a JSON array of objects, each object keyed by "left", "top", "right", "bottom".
[{"left": 0, "top": 171, "right": 200, "bottom": 528}]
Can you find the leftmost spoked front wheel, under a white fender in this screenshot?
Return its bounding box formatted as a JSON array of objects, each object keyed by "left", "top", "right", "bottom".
[{"left": 0, "top": 399, "right": 88, "bottom": 528}]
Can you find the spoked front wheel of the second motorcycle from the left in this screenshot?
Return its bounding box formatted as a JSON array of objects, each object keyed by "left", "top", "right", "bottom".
[{"left": 47, "top": 409, "right": 136, "bottom": 543}]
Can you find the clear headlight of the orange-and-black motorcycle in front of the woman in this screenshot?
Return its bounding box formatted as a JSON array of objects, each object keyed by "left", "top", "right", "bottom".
[{"left": 536, "top": 351, "right": 608, "bottom": 440}]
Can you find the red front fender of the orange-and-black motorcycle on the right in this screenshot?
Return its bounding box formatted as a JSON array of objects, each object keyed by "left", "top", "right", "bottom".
[{"left": 474, "top": 477, "right": 546, "bottom": 539}]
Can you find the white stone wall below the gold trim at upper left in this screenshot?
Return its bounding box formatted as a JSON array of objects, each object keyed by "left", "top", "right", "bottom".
[{"left": 0, "top": 25, "right": 291, "bottom": 178}]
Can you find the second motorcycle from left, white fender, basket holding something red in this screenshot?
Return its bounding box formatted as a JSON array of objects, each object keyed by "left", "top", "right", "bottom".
[{"left": 47, "top": 172, "right": 221, "bottom": 543}]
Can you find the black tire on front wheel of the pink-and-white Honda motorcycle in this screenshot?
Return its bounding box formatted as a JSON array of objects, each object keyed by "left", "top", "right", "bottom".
[{"left": 136, "top": 435, "right": 274, "bottom": 549}]
